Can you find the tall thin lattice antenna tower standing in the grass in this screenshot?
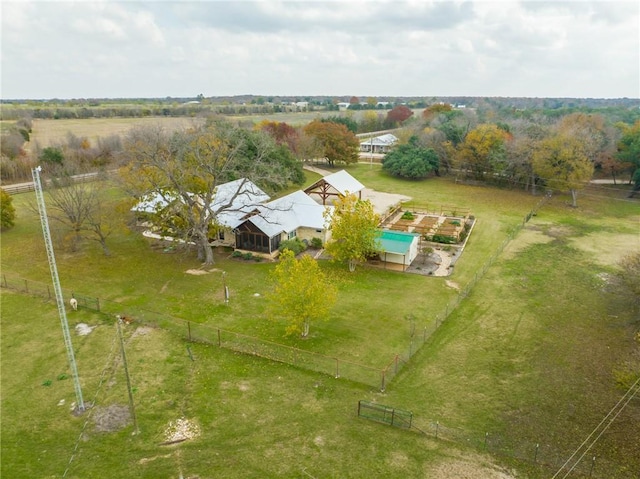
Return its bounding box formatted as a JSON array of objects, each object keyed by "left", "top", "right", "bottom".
[{"left": 31, "top": 166, "right": 84, "bottom": 412}]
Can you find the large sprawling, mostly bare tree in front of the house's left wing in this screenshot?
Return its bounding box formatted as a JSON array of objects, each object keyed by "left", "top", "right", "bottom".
[{"left": 123, "top": 121, "right": 304, "bottom": 264}]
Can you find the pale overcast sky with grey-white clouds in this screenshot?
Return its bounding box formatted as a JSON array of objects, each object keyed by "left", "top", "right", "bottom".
[{"left": 0, "top": 0, "right": 640, "bottom": 100}]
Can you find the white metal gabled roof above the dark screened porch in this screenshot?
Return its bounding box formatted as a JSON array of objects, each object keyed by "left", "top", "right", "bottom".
[{"left": 247, "top": 191, "right": 331, "bottom": 238}]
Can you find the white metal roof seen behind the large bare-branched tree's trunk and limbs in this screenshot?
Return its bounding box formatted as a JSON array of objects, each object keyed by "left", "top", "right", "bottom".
[{"left": 131, "top": 178, "right": 269, "bottom": 228}]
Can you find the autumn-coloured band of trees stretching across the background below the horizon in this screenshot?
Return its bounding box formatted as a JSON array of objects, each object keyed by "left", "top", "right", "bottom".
[{"left": 0, "top": 97, "right": 640, "bottom": 201}]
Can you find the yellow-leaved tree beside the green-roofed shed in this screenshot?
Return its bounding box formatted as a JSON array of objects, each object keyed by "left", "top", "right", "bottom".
[{"left": 325, "top": 194, "right": 380, "bottom": 272}]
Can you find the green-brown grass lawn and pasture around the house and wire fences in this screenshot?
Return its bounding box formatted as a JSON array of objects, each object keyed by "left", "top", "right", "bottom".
[{"left": 0, "top": 165, "right": 640, "bottom": 479}]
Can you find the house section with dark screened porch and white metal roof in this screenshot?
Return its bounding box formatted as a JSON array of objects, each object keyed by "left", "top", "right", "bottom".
[{"left": 235, "top": 191, "right": 333, "bottom": 256}]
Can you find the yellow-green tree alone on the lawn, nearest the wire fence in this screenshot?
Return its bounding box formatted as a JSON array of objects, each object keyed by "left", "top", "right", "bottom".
[{"left": 268, "top": 249, "right": 337, "bottom": 338}]
